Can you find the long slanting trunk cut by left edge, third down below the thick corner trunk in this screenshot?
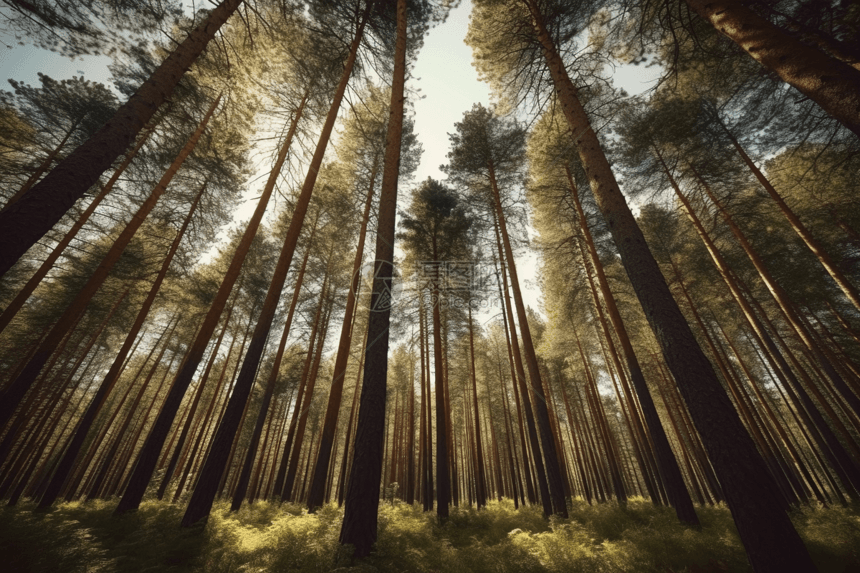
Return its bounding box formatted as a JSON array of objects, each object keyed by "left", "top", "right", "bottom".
[{"left": 0, "top": 95, "right": 221, "bottom": 427}]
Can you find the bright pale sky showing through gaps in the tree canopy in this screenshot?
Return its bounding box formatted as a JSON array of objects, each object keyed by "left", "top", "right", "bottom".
[{"left": 0, "top": 0, "right": 658, "bottom": 326}]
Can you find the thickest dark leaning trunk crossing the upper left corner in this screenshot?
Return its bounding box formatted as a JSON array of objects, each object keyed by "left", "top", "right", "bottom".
[{"left": 0, "top": 0, "right": 242, "bottom": 276}]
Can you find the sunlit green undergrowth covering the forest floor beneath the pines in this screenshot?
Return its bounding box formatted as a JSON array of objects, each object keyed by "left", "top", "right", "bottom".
[{"left": 0, "top": 499, "right": 860, "bottom": 573}]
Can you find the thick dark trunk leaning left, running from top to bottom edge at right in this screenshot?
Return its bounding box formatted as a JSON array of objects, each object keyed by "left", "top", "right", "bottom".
[{"left": 524, "top": 0, "right": 815, "bottom": 572}]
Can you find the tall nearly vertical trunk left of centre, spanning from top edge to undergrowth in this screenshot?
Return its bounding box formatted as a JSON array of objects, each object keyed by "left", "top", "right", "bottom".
[{"left": 340, "top": 0, "right": 406, "bottom": 557}]
